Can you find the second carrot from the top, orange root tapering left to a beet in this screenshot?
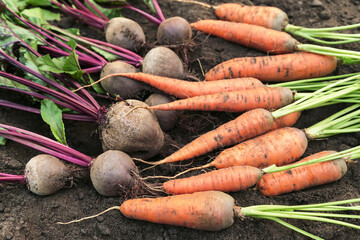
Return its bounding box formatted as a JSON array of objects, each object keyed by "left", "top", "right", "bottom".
[{"left": 191, "top": 20, "right": 298, "bottom": 54}]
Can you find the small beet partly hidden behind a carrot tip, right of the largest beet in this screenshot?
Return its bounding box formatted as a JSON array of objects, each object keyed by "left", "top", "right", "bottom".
[{"left": 145, "top": 93, "right": 178, "bottom": 132}]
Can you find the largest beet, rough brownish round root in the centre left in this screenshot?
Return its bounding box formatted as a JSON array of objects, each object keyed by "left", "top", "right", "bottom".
[{"left": 101, "top": 99, "right": 164, "bottom": 159}]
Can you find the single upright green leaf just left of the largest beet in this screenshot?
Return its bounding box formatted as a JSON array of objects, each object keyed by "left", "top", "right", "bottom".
[{"left": 41, "top": 99, "right": 67, "bottom": 145}]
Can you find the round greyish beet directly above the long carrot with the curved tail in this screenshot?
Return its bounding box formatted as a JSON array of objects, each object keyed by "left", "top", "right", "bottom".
[{"left": 142, "top": 47, "right": 185, "bottom": 79}]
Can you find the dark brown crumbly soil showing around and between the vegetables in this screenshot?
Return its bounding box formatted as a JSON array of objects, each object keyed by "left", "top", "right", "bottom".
[{"left": 0, "top": 0, "right": 360, "bottom": 240}]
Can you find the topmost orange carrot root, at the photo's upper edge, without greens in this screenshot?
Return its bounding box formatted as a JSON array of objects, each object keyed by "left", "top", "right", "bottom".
[{"left": 215, "top": 3, "right": 289, "bottom": 31}]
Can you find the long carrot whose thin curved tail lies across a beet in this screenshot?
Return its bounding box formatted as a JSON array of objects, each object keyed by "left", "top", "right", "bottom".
[{"left": 99, "top": 73, "right": 264, "bottom": 98}]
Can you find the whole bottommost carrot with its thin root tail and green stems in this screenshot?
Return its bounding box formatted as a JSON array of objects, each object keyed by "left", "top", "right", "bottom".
[{"left": 58, "top": 191, "right": 360, "bottom": 239}]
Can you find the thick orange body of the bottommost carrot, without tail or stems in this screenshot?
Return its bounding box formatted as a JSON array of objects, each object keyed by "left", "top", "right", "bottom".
[{"left": 120, "top": 191, "right": 234, "bottom": 231}]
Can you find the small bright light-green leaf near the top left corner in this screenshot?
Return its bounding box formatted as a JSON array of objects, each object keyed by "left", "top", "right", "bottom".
[{"left": 21, "top": 7, "right": 60, "bottom": 26}]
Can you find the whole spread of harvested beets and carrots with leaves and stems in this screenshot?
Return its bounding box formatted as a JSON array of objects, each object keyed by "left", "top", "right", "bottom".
[{"left": 0, "top": 0, "right": 360, "bottom": 239}]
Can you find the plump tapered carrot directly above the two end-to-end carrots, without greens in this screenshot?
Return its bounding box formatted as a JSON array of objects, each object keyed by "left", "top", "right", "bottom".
[{"left": 207, "top": 127, "right": 308, "bottom": 168}]
